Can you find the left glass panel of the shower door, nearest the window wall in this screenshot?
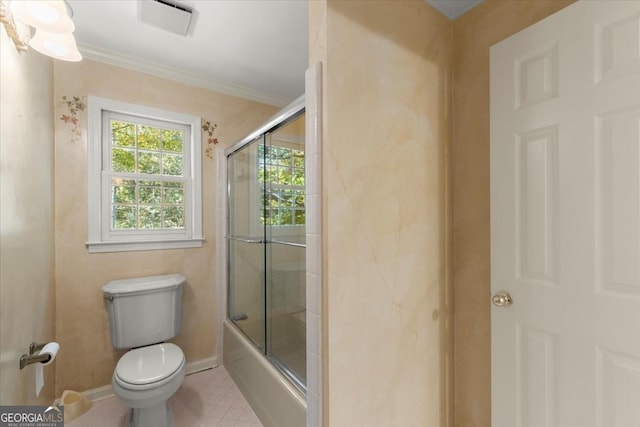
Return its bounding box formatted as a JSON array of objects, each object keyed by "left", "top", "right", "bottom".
[{"left": 227, "top": 136, "right": 266, "bottom": 351}]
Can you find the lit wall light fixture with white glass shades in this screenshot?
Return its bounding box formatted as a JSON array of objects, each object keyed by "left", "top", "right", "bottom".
[{"left": 0, "top": 0, "right": 82, "bottom": 61}]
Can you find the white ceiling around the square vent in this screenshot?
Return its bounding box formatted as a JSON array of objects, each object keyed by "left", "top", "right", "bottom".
[{"left": 68, "top": 0, "right": 479, "bottom": 106}]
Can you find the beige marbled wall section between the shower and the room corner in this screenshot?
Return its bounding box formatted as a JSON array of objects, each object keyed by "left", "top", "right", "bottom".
[{"left": 310, "top": 0, "right": 451, "bottom": 427}]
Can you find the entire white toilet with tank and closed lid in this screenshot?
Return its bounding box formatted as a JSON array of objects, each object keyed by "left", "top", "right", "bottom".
[{"left": 102, "top": 274, "right": 185, "bottom": 427}]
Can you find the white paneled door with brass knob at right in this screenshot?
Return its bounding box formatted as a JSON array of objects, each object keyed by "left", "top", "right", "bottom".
[{"left": 487, "top": 0, "right": 640, "bottom": 427}]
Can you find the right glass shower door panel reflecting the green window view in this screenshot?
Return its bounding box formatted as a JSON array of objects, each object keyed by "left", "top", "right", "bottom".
[{"left": 263, "top": 113, "right": 307, "bottom": 390}]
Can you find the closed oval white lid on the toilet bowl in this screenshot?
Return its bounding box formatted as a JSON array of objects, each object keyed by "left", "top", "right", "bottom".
[{"left": 116, "top": 343, "right": 184, "bottom": 385}]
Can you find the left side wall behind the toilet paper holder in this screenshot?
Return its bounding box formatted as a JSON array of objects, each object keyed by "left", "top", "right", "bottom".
[{"left": 0, "top": 28, "right": 57, "bottom": 405}]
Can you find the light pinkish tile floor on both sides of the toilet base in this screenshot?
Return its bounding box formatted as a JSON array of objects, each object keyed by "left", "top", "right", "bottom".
[{"left": 65, "top": 366, "right": 262, "bottom": 427}]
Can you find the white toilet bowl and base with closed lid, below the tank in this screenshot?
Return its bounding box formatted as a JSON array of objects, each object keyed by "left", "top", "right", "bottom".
[{"left": 111, "top": 343, "right": 185, "bottom": 427}]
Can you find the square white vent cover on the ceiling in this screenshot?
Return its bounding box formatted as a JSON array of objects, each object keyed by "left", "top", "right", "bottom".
[{"left": 138, "top": 0, "right": 193, "bottom": 36}]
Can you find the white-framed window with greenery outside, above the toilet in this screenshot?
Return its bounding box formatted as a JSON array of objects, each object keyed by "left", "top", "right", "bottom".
[{"left": 87, "top": 97, "right": 203, "bottom": 252}]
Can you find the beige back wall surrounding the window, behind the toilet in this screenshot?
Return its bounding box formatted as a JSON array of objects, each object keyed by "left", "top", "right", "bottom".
[{"left": 54, "top": 60, "right": 278, "bottom": 392}]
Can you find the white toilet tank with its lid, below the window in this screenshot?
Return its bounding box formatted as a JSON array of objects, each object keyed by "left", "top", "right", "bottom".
[{"left": 102, "top": 274, "right": 185, "bottom": 348}]
